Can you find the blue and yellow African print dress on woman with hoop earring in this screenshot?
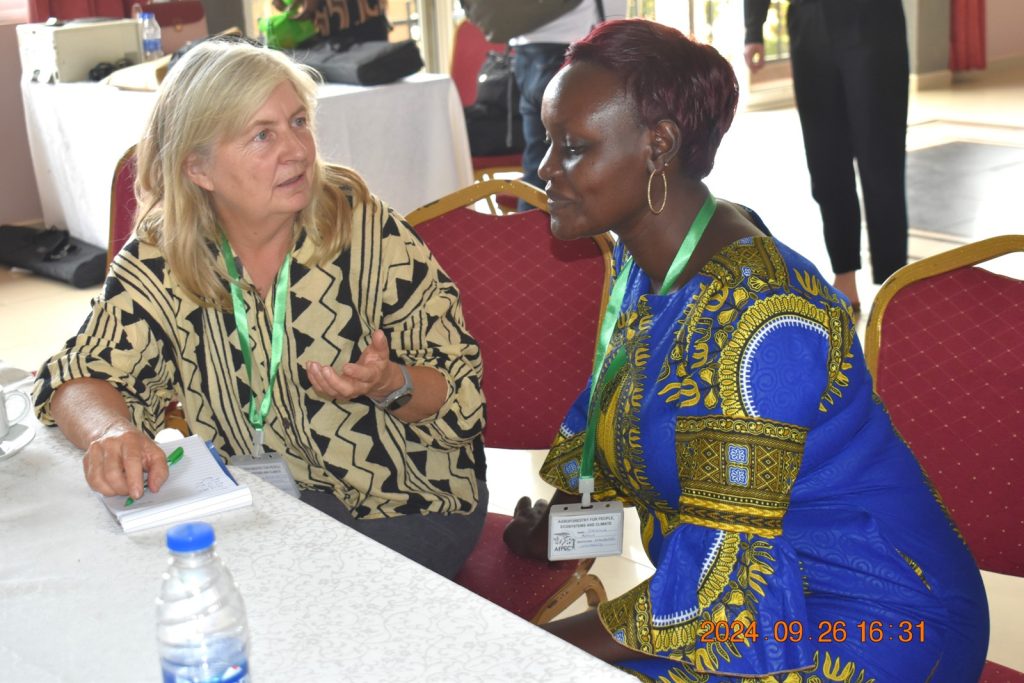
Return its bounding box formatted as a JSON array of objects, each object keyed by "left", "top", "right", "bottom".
[{"left": 542, "top": 238, "right": 988, "bottom": 683}]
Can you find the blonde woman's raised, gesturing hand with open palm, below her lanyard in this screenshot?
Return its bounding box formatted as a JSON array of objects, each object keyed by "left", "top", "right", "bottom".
[{"left": 306, "top": 330, "right": 404, "bottom": 400}]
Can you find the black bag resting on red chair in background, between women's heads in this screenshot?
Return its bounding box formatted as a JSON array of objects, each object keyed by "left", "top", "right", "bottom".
[{"left": 464, "top": 51, "right": 524, "bottom": 157}]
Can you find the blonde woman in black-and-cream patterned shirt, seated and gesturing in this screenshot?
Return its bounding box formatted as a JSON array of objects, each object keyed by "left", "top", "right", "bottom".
[{"left": 35, "top": 40, "right": 486, "bottom": 577}]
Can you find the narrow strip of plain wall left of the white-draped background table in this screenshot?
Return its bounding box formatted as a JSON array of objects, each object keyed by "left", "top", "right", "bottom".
[{"left": 0, "top": 24, "right": 43, "bottom": 223}]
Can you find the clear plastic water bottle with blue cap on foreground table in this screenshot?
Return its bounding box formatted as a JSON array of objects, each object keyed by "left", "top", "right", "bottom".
[{"left": 157, "top": 522, "right": 251, "bottom": 683}]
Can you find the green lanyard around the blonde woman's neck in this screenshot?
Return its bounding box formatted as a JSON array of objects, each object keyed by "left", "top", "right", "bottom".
[{"left": 220, "top": 232, "right": 292, "bottom": 457}]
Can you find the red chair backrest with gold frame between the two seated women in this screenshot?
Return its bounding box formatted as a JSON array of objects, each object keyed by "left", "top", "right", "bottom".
[{"left": 409, "top": 180, "right": 611, "bottom": 449}]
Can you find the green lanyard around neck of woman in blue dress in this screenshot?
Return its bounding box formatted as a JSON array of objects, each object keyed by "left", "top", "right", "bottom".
[{"left": 580, "top": 193, "right": 715, "bottom": 507}]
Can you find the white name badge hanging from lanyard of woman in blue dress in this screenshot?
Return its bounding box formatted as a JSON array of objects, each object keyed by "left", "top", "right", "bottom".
[{"left": 548, "top": 501, "right": 623, "bottom": 561}]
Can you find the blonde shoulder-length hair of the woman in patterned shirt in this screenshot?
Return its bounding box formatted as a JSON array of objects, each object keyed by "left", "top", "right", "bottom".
[{"left": 135, "top": 39, "right": 369, "bottom": 308}]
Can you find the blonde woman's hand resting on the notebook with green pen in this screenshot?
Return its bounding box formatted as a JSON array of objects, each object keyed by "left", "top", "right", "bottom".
[{"left": 82, "top": 423, "right": 168, "bottom": 499}]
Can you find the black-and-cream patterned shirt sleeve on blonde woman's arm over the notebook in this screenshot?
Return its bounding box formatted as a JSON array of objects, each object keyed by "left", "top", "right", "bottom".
[{"left": 33, "top": 248, "right": 176, "bottom": 435}]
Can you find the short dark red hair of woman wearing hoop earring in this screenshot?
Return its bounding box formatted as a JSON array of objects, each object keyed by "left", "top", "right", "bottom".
[{"left": 565, "top": 19, "right": 739, "bottom": 180}]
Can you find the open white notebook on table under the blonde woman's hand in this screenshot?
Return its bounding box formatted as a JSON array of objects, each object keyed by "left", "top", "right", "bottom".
[{"left": 102, "top": 435, "right": 253, "bottom": 533}]
